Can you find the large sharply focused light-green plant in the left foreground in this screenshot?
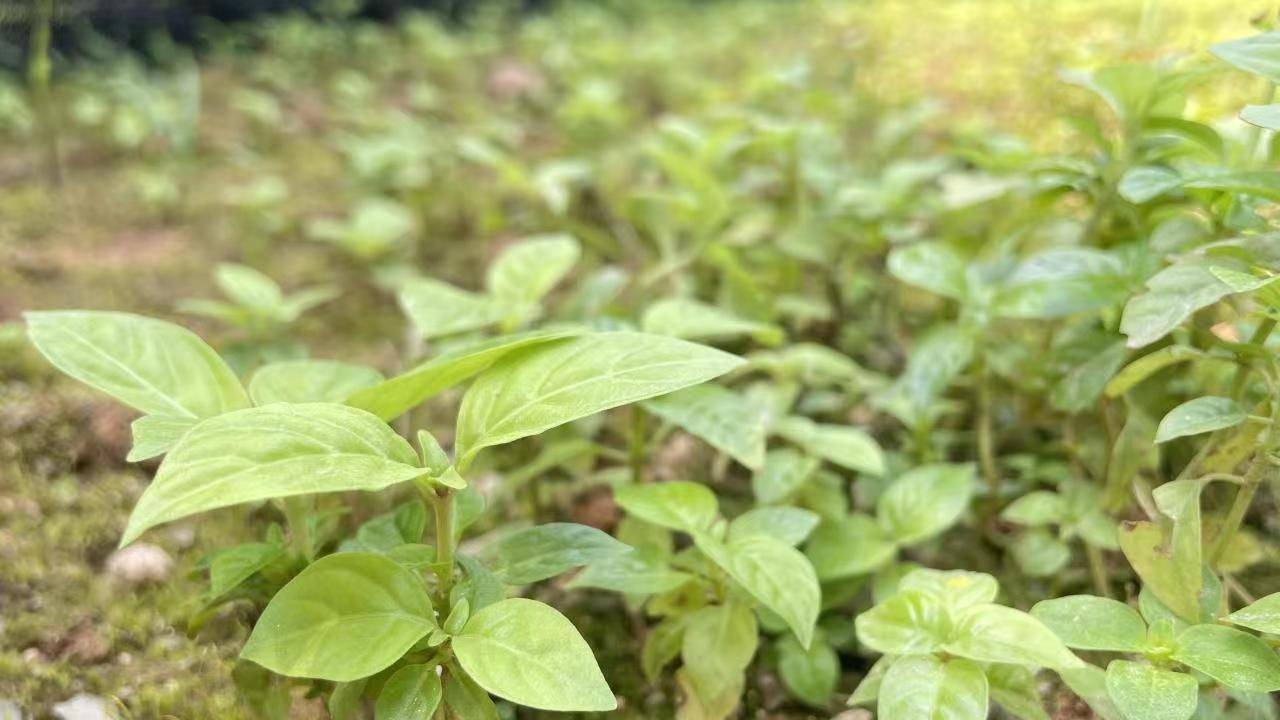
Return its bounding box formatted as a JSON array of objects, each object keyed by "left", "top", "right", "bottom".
[{"left": 27, "top": 311, "right": 742, "bottom": 717}]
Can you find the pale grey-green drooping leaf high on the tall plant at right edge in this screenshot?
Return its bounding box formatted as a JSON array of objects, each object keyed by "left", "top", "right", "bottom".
[{"left": 1120, "top": 263, "right": 1231, "bottom": 347}]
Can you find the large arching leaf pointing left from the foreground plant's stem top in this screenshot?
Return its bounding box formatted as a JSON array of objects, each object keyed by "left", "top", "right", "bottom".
[{"left": 120, "top": 402, "right": 426, "bottom": 544}]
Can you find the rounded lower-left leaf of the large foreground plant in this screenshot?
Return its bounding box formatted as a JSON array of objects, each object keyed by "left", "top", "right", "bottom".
[{"left": 241, "top": 552, "right": 435, "bottom": 682}]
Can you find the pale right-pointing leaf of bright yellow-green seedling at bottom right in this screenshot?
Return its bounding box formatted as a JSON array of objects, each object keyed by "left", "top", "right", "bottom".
[{"left": 942, "top": 603, "right": 1080, "bottom": 669}]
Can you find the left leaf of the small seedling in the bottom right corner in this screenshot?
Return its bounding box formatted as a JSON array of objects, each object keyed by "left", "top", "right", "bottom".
[{"left": 1032, "top": 594, "right": 1147, "bottom": 652}]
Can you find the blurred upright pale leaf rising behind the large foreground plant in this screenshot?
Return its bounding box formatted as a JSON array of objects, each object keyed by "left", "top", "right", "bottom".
[{"left": 485, "top": 234, "right": 582, "bottom": 305}]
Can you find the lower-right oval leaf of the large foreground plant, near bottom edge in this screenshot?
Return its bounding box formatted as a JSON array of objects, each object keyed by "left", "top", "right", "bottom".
[{"left": 453, "top": 597, "right": 618, "bottom": 712}]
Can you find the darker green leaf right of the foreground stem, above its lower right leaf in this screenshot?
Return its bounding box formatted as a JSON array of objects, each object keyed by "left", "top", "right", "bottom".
[{"left": 485, "top": 523, "right": 631, "bottom": 585}]
